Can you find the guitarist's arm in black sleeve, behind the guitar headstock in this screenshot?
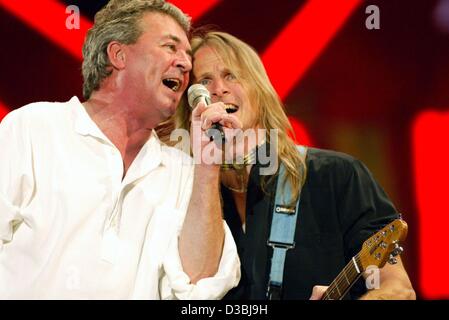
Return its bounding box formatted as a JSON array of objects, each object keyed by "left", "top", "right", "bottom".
[{"left": 311, "top": 155, "right": 415, "bottom": 300}]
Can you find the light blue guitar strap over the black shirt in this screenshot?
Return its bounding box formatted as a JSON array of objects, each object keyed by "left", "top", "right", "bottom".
[{"left": 267, "top": 146, "right": 307, "bottom": 300}]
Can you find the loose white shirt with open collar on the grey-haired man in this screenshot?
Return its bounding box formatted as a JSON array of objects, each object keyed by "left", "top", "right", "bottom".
[{"left": 0, "top": 97, "right": 240, "bottom": 299}]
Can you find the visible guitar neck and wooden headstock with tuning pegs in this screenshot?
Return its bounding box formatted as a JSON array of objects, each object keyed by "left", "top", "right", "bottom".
[{"left": 322, "top": 219, "right": 408, "bottom": 300}]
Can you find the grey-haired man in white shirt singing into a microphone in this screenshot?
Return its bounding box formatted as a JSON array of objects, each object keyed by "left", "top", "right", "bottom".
[{"left": 0, "top": 0, "right": 241, "bottom": 299}]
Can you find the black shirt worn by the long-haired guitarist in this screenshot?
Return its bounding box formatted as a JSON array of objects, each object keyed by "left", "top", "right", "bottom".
[{"left": 221, "top": 148, "right": 398, "bottom": 299}]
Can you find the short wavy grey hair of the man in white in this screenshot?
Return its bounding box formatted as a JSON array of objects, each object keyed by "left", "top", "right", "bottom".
[{"left": 82, "top": 0, "right": 190, "bottom": 99}]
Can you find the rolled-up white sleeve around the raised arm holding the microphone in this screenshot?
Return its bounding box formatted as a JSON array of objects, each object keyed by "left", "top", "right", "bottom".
[{"left": 160, "top": 221, "right": 240, "bottom": 300}]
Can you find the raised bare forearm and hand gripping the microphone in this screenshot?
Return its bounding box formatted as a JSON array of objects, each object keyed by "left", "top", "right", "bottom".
[{"left": 179, "top": 103, "right": 241, "bottom": 283}]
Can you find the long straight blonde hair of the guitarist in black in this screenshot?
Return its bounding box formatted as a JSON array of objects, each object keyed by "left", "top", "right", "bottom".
[{"left": 175, "top": 31, "right": 306, "bottom": 202}]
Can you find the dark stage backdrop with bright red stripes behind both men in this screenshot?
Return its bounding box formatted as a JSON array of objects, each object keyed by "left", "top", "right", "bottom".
[{"left": 0, "top": 0, "right": 449, "bottom": 299}]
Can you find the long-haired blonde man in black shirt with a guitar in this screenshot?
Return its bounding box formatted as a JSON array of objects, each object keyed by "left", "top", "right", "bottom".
[{"left": 173, "top": 31, "right": 415, "bottom": 299}]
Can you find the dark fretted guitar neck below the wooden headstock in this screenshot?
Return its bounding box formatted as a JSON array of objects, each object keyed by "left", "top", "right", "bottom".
[{"left": 322, "top": 254, "right": 364, "bottom": 300}]
